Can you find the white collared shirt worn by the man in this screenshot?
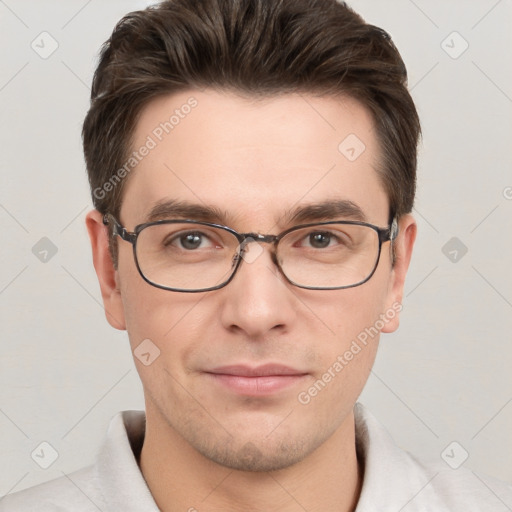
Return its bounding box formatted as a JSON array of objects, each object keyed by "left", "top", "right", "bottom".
[{"left": 0, "top": 404, "right": 512, "bottom": 512}]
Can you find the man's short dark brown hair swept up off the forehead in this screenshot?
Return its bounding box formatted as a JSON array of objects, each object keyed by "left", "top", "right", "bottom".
[{"left": 82, "top": 0, "right": 420, "bottom": 262}]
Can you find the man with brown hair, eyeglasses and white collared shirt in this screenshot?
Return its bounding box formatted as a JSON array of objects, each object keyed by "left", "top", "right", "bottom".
[{"left": 0, "top": 0, "right": 512, "bottom": 512}]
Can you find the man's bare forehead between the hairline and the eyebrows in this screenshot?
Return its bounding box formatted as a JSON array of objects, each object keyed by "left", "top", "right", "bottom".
[{"left": 121, "top": 89, "right": 388, "bottom": 229}]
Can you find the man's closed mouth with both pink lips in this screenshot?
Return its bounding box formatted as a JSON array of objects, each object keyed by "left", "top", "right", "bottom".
[{"left": 205, "top": 364, "right": 308, "bottom": 397}]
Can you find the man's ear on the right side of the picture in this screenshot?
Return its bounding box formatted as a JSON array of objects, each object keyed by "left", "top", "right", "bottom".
[{"left": 382, "top": 214, "right": 417, "bottom": 333}]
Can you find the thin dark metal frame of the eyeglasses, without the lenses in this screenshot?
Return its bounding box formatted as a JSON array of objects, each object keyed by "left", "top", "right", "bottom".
[{"left": 103, "top": 213, "right": 398, "bottom": 293}]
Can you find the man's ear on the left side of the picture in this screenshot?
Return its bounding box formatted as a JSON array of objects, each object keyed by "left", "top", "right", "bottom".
[{"left": 85, "top": 210, "right": 126, "bottom": 330}]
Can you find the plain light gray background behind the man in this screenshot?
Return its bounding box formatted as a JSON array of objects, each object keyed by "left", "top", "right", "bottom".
[{"left": 0, "top": 0, "right": 512, "bottom": 496}]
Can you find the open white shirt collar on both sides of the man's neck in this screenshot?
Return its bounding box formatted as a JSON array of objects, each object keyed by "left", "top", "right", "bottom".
[{"left": 95, "top": 403, "right": 442, "bottom": 512}]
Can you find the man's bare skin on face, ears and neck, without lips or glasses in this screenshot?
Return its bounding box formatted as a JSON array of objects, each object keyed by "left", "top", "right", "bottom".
[{"left": 87, "top": 89, "right": 416, "bottom": 512}]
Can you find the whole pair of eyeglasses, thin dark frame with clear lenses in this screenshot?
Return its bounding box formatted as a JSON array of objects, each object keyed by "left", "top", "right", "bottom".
[{"left": 103, "top": 213, "right": 398, "bottom": 292}]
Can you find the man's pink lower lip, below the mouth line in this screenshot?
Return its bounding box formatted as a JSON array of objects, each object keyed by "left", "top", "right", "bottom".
[{"left": 208, "top": 373, "right": 306, "bottom": 396}]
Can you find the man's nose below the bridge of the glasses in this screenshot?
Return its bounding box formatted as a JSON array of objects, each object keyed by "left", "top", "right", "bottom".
[{"left": 221, "top": 241, "right": 298, "bottom": 339}]
